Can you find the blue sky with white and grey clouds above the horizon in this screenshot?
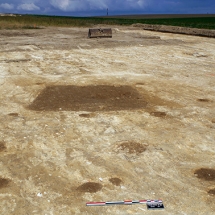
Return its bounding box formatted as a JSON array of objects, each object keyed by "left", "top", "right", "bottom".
[{"left": 0, "top": 0, "right": 215, "bottom": 16}]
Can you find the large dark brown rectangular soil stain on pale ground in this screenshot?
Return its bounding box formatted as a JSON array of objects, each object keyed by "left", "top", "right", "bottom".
[{"left": 29, "top": 85, "right": 147, "bottom": 111}]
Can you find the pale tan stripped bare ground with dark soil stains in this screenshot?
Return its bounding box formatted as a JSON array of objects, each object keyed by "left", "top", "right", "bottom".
[{"left": 0, "top": 26, "right": 215, "bottom": 215}]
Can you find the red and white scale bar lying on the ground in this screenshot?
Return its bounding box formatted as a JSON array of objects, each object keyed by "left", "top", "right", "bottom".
[{"left": 86, "top": 200, "right": 163, "bottom": 206}]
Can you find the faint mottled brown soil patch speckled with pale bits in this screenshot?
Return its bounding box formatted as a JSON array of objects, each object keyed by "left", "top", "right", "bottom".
[{"left": 118, "top": 142, "right": 147, "bottom": 155}]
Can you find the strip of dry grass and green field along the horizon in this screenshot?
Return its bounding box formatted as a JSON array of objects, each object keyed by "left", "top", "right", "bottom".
[{"left": 0, "top": 15, "right": 215, "bottom": 29}]
